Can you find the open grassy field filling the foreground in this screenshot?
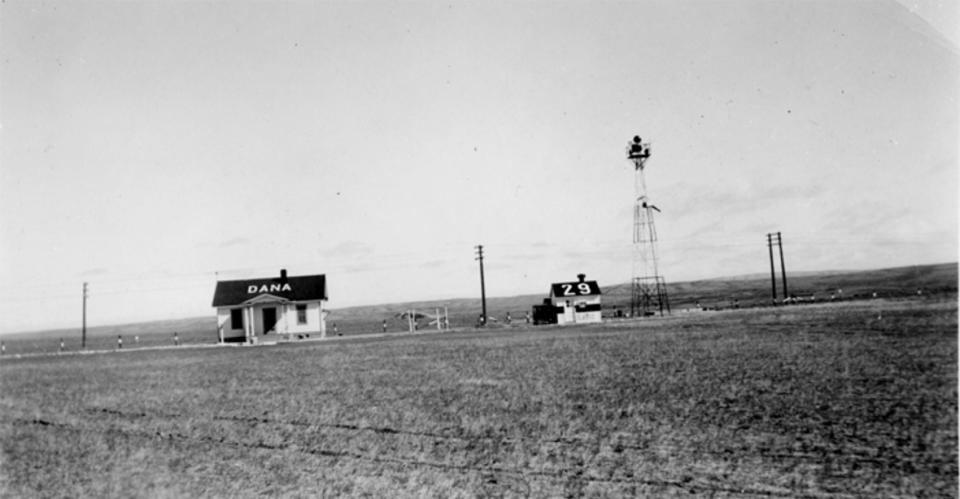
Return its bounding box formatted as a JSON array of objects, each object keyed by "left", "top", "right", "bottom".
[{"left": 0, "top": 296, "right": 958, "bottom": 497}]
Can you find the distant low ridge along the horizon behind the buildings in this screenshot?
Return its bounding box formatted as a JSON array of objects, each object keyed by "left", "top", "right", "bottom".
[{"left": 0, "top": 262, "right": 958, "bottom": 340}]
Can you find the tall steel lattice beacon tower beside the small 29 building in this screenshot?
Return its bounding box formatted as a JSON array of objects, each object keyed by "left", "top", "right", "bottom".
[{"left": 627, "top": 137, "right": 670, "bottom": 317}]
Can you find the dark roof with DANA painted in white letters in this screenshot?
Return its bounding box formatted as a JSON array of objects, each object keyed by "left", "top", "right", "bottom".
[{"left": 213, "top": 274, "right": 327, "bottom": 307}]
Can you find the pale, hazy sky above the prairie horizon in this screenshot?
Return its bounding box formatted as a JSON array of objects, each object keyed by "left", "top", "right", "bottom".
[{"left": 0, "top": 0, "right": 960, "bottom": 333}]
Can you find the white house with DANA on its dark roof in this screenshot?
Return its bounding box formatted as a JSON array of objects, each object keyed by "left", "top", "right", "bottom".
[{"left": 213, "top": 270, "right": 327, "bottom": 343}]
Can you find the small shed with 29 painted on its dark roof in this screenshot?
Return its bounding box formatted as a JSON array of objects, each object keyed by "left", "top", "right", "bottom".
[{"left": 533, "top": 274, "right": 602, "bottom": 325}]
